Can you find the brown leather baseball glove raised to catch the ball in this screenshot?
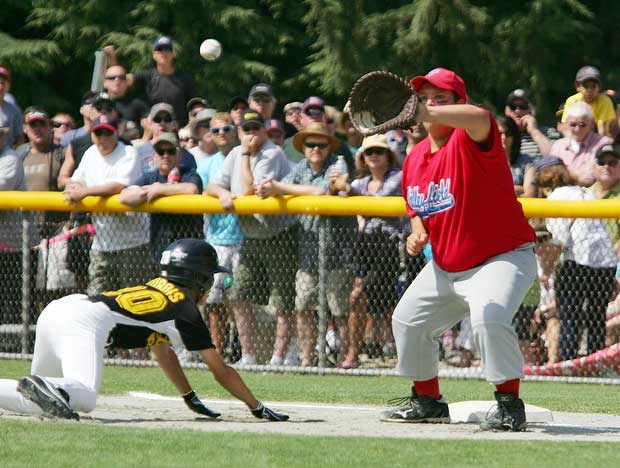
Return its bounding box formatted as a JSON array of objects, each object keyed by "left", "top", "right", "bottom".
[{"left": 347, "top": 71, "right": 418, "bottom": 136}]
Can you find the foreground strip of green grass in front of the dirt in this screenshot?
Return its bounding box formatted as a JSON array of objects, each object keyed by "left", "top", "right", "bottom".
[{"left": 0, "top": 420, "right": 620, "bottom": 468}]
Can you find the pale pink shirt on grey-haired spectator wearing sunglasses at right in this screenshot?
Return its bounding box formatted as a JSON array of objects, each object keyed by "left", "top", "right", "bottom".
[{"left": 549, "top": 132, "right": 613, "bottom": 186}]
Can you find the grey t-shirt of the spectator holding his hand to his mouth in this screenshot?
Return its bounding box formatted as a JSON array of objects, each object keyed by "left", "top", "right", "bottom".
[{"left": 211, "top": 140, "right": 297, "bottom": 239}]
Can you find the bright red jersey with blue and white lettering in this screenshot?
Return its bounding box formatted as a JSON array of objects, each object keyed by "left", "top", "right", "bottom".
[{"left": 402, "top": 114, "right": 536, "bottom": 272}]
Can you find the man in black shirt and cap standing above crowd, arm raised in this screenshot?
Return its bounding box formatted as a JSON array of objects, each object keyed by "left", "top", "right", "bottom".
[{"left": 103, "top": 36, "right": 198, "bottom": 127}]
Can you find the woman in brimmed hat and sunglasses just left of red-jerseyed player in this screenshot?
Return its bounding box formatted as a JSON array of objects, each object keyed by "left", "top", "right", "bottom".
[{"left": 340, "top": 135, "right": 407, "bottom": 369}]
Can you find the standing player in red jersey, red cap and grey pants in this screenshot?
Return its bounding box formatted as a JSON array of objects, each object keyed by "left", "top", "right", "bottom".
[{"left": 382, "top": 68, "right": 536, "bottom": 431}]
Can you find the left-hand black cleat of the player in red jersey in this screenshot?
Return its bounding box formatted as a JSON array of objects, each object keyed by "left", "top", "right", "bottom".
[{"left": 381, "top": 388, "right": 450, "bottom": 424}]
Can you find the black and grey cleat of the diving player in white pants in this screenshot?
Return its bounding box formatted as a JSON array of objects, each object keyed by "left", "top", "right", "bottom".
[{"left": 17, "top": 375, "right": 80, "bottom": 421}]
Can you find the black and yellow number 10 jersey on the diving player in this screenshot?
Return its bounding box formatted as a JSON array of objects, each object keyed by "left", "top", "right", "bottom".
[{"left": 88, "top": 277, "right": 213, "bottom": 351}]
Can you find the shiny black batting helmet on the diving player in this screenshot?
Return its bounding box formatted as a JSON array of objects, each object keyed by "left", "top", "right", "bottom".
[{"left": 159, "top": 239, "right": 231, "bottom": 292}]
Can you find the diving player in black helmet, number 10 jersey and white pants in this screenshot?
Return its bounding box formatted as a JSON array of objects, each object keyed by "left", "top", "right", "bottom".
[{"left": 0, "top": 239, "right": 288, "bottom": 421}]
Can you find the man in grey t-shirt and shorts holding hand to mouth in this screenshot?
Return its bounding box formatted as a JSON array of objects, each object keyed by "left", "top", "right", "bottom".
[{"left": 205, "top": 109, "right": 299, "bottom": 365}]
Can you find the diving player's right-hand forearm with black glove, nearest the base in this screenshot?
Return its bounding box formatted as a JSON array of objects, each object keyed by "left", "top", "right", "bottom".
[{"left": 198, "top": 349, "right": 288, "bottom": 421}]
